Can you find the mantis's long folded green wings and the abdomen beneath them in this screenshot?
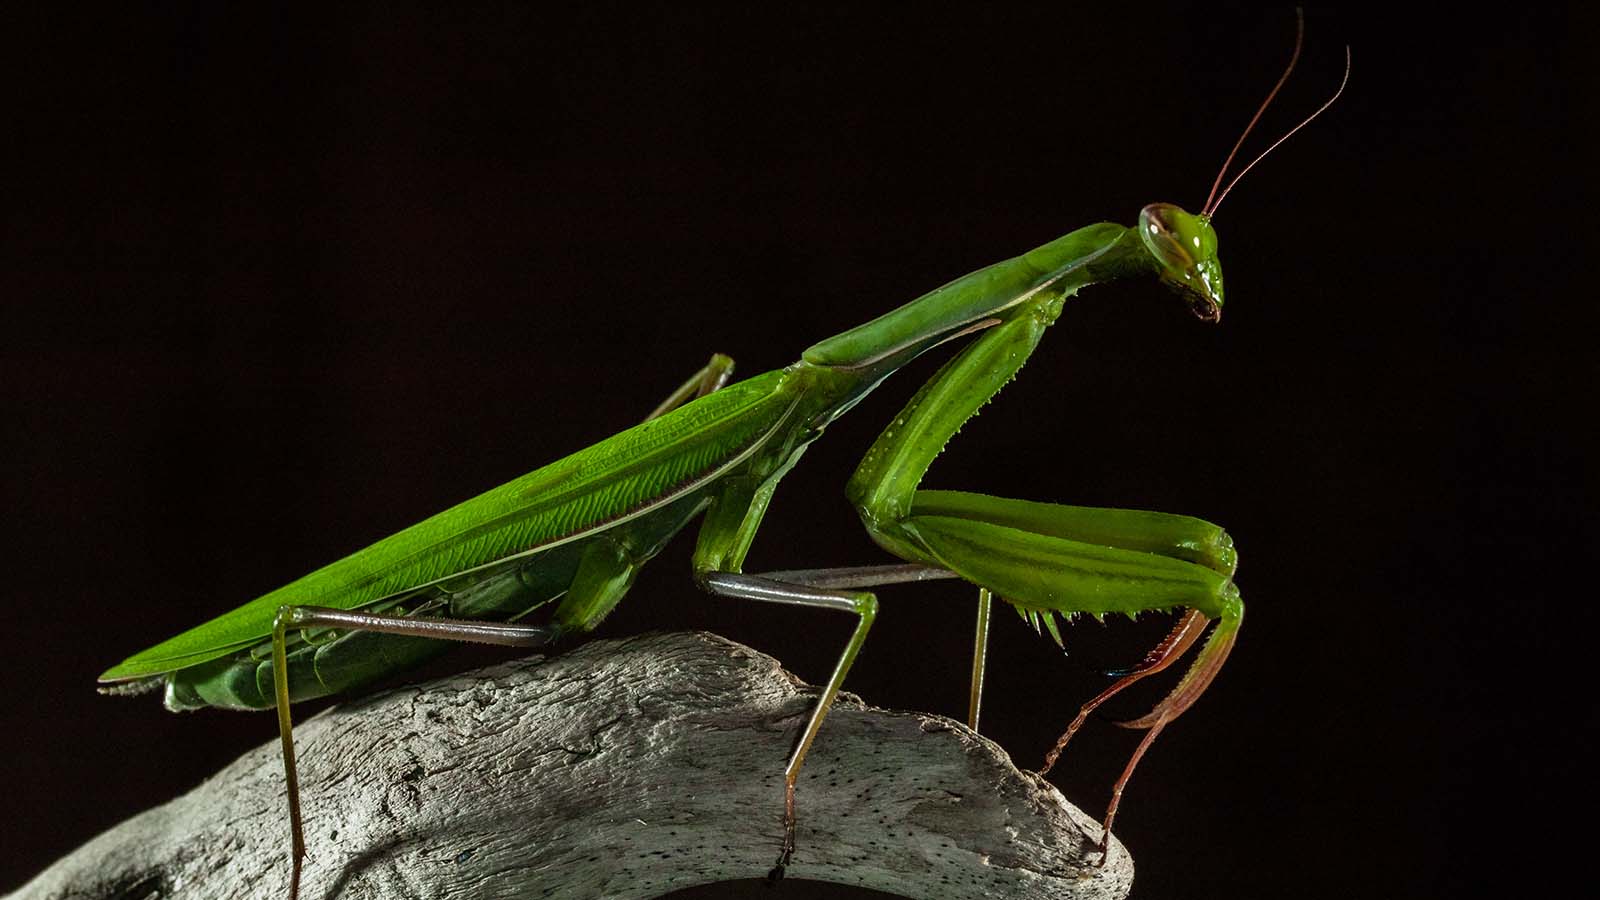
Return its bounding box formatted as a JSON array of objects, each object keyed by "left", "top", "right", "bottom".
[{"left": 101, "top": 372, "right": 806, "bottom": 708}]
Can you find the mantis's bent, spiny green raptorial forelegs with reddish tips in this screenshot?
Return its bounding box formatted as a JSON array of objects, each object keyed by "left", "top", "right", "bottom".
[{"left": 848, "top": 285, "right": 1243, "bottom": 852}]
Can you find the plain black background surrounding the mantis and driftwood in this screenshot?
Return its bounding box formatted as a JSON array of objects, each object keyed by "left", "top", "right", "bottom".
[{"left": 0, "top": 3, "right": 1595, "bottom": 898}]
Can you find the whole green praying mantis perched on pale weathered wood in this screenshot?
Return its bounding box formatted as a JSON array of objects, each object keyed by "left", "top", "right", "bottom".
[{"left": 99, "top": 17, "right": 1349, "bottom": 895}]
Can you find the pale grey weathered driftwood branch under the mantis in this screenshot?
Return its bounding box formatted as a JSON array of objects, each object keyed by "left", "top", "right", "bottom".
[{"left": 14, "top": 633, "right": 1133, "bottom": 900}]
